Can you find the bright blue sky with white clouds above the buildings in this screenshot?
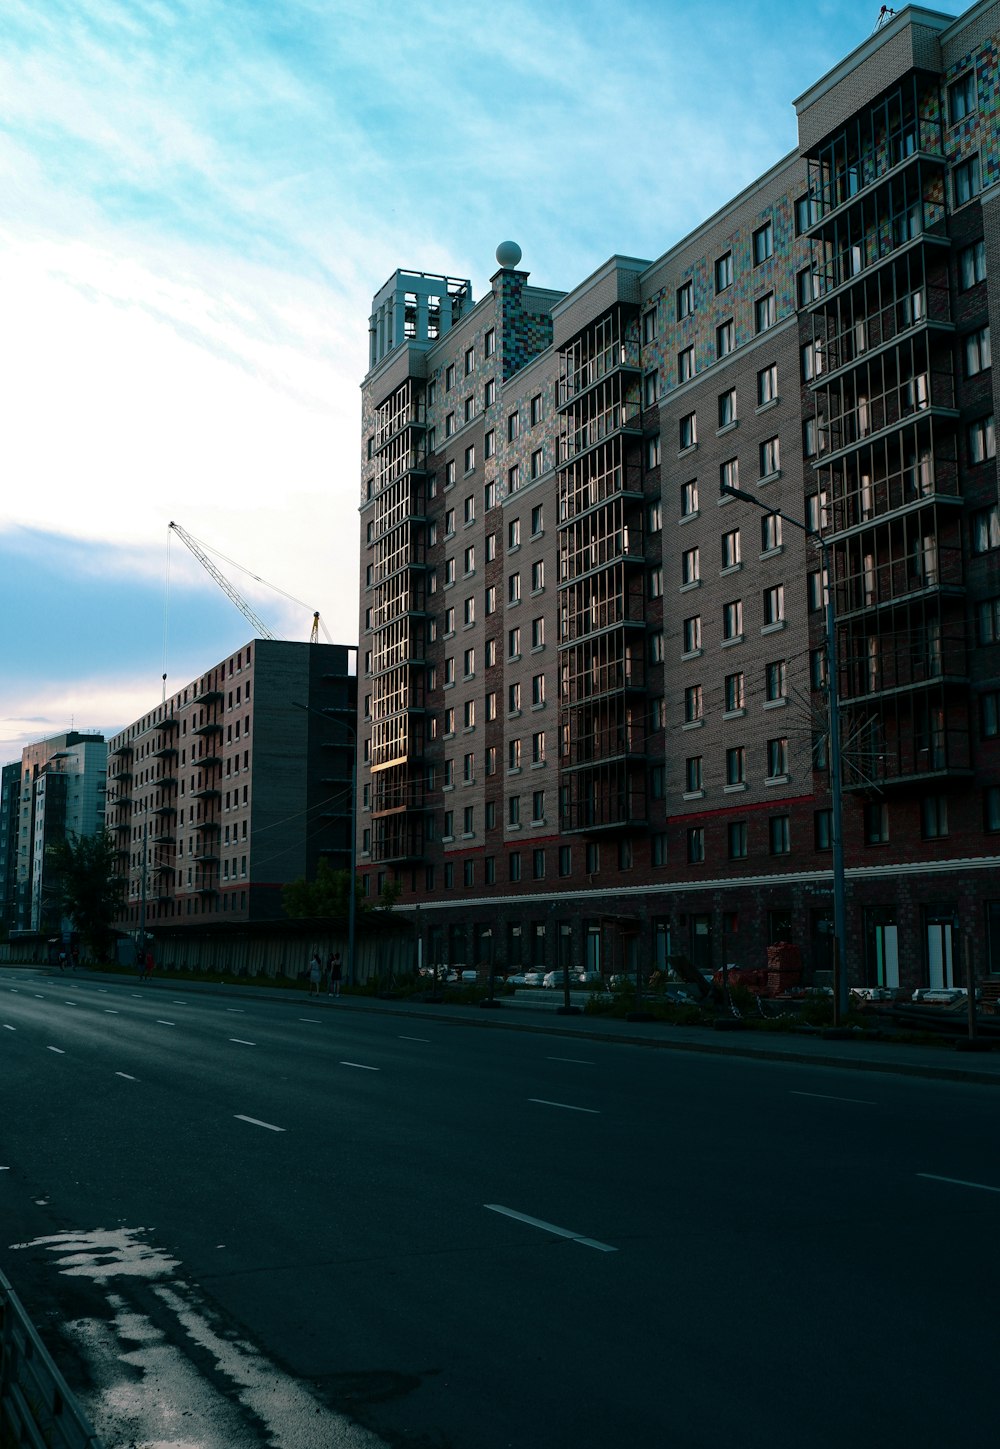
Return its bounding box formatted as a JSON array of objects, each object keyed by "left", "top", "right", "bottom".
[{"left": 0, "top": 0, "right": 959, "bottom": 761}]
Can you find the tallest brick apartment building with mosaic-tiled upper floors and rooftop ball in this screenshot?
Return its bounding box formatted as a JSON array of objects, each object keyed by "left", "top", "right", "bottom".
[{"left": 358, "top": 0, "right": 1000, "bottom": 987}]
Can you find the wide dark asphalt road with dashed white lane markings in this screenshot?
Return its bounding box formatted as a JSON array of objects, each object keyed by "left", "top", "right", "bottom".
[{"left": 0, "top": 969, "right": 1000, "bottom": 1449}]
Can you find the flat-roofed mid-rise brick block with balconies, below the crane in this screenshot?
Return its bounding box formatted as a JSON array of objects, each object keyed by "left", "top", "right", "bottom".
[{"left": 107, "top": 639, "right": 357, "bottom": 940}]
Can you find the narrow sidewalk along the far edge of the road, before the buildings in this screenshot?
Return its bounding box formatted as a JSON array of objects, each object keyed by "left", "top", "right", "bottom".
[{"left": 22, "top": 966, "right": 1000, "bottom": 1087}]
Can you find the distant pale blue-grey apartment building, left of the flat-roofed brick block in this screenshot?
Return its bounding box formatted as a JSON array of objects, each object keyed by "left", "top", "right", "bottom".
[{"left": 4, "top": 730, "right": 107, "bottom": 936}]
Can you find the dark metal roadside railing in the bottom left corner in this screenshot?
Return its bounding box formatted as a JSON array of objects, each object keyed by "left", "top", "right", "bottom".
[{"left": 0, "top": 1272, "right": 103, "bottom": 1449}]
